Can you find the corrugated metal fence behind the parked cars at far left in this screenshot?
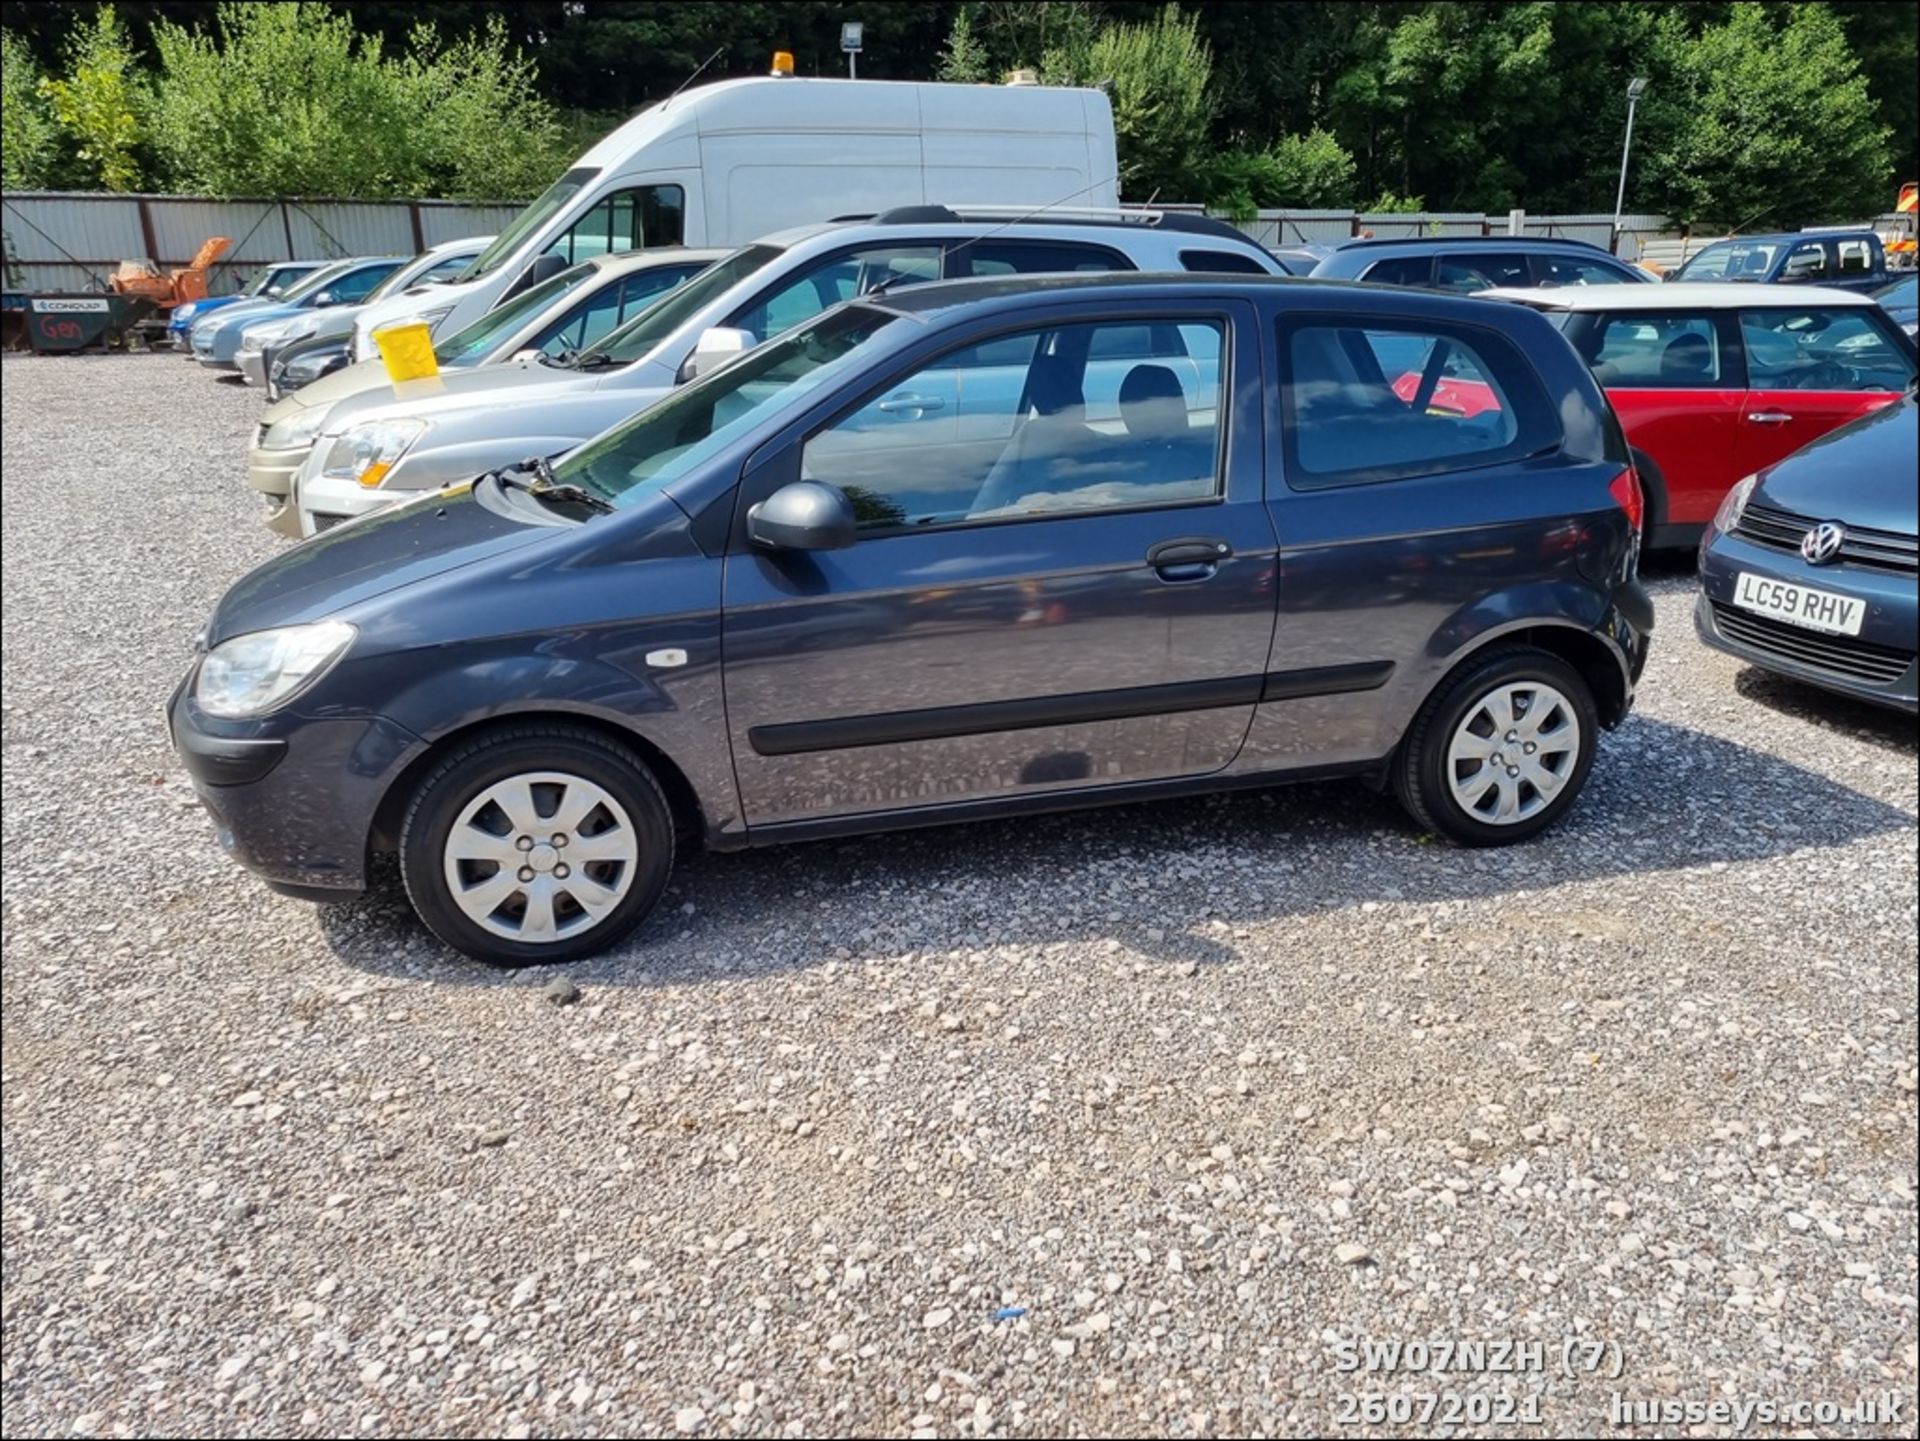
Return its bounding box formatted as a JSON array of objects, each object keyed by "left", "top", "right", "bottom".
[{"left": 0, "top": 192, "right": 520, "bottom": 295}]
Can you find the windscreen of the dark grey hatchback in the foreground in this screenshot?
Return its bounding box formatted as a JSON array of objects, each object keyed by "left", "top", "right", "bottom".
[{"left": 553, "top": 305, "right": 902, "bottom": 505}]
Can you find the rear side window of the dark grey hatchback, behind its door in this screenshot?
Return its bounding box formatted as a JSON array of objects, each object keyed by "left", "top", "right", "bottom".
[{"left": 1281, "top": 319, "right": 1561, "bottom": 489}]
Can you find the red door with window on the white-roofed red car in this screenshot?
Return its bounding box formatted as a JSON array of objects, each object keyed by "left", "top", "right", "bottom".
[{"left": 1740, "top": 303, "right": 1914, "bottom": 485}]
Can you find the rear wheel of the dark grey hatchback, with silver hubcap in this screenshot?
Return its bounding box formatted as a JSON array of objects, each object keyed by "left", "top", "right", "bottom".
[{"left": 1394, "top": 647, "right": 1599, "bottom": 846}]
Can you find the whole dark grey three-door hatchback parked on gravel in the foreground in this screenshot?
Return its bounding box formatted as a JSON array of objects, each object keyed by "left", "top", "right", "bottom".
[{"left": 169, "top": 274, "right": 1653, "bottom": 963}]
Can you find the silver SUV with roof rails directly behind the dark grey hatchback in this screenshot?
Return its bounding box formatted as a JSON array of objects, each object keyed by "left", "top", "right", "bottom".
[{"left": 294, "top": 205, "right": 1281, "bottom": 535}]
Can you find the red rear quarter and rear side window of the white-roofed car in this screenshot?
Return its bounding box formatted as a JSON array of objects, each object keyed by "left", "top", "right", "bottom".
[{"left": 1576, "top": 309, "right": 1747, "bottom": 526}]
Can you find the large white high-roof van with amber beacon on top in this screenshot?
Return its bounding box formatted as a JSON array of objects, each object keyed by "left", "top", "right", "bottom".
[{"left": 353, "top": 77, "right": 1119, "bottom": 361}]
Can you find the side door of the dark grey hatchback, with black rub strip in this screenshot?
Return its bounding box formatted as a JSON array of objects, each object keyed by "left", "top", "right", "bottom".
[{"left": 724, "top": 301, "right": 1275, "bottom": 825}]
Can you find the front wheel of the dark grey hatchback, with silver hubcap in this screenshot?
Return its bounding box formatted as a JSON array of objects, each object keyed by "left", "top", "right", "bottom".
[{"left": 399, "top": 723, "right": 674, "bottom": 965}]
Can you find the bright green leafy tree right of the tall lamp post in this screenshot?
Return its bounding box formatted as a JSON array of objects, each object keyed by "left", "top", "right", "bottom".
[{"left": 1636, "top": 0, "right": 1889, "bottom": 226}]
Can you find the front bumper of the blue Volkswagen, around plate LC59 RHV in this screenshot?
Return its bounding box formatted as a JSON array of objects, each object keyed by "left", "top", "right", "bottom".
[{"left": 1693, "top": 528, "right": 1920, "bottom": 714}]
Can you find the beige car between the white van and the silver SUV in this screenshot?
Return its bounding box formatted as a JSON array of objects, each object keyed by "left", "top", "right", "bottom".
[{"left": 246, "top": 246, "right": 728, "bottom": 539}]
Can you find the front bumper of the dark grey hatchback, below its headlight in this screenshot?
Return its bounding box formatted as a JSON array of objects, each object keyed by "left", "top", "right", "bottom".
[{"left": 167, "top": 668, "right": 420, "bottom": 898}]
